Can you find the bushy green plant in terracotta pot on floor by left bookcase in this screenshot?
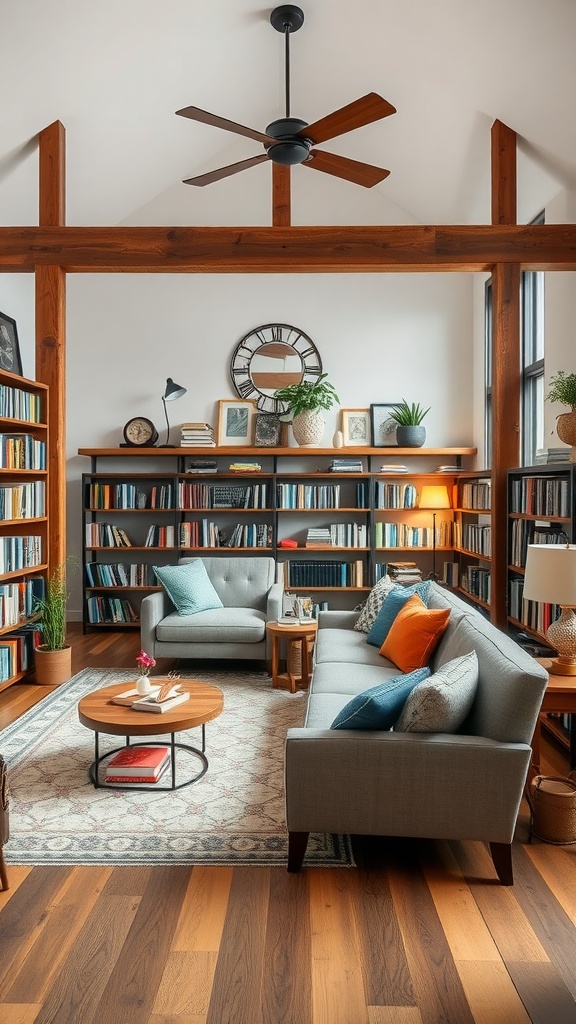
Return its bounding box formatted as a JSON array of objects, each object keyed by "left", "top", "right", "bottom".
[{"left": 34, "top": 564, "right": 72, "bottom": 686}]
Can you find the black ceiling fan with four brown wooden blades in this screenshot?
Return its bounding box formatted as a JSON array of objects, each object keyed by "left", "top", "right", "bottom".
[{"left": 176, "top": 4, "right": 396, "bottom": 188}]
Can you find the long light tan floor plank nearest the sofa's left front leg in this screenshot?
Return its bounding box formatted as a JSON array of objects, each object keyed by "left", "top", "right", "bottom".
[{"left": 308, "top": 868, "right": 368, "bottom": 1024}]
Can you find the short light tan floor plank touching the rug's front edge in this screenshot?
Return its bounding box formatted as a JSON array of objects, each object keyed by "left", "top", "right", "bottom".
[{"left": 172, "top": 865, "right": 233, "bottom": 952}]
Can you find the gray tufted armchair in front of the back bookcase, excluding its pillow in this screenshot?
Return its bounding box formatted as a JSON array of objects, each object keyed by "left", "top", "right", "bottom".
[{"left": 140, "top": 555, "right": 284, "bottom": 659}]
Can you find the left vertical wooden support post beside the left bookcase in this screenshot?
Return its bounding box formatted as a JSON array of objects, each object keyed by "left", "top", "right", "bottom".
[{"left": 35, "top": 121, "right": 67, "bottom": 569}]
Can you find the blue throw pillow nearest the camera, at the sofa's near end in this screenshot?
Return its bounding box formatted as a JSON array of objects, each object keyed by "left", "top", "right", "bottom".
[{"left": 330, "top": 666, "right": 430, "bottom": 729}]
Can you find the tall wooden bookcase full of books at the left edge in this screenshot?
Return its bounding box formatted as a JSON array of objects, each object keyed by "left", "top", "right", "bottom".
[{"left": 0, "top": 371, "right": 49, "bottom": 690}]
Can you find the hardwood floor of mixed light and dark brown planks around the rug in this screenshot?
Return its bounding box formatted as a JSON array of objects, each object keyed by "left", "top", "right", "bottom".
[{"left": 0, "top": 627, "right": 576, "bottom": 1024}]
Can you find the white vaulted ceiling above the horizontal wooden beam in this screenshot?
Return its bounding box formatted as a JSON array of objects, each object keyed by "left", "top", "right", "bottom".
[{"left": 0, "top": 0, "right": 576, "bottom": 225}]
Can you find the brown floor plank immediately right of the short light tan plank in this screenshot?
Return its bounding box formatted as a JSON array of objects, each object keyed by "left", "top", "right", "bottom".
[{"left": 206, "top": 867, "right": 270, "bottom": 1024}]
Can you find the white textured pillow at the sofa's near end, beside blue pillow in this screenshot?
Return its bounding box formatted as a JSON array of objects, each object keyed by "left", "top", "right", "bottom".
[{"left": 394, "top": 650, "right": 478, "bottom": 732}]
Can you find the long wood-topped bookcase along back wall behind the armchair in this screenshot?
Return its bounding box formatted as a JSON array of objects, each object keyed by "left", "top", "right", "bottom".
[{"left": 79, "top": 446, "right": 476, "bottom": 630}]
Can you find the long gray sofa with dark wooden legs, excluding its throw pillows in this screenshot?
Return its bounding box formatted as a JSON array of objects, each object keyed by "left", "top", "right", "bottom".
[{"left": 285, "top": 584, "right": 547, "bottom": 885}]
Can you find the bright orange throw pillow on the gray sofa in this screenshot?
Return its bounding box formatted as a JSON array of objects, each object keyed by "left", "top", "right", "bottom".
[{"left": 380, "top": 594, "right": 450, "bottom": 672}]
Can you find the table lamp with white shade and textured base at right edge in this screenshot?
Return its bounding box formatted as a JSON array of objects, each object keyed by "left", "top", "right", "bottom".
[{"left": 523, "top": 544, "right": 576, "bottom": 676}]
